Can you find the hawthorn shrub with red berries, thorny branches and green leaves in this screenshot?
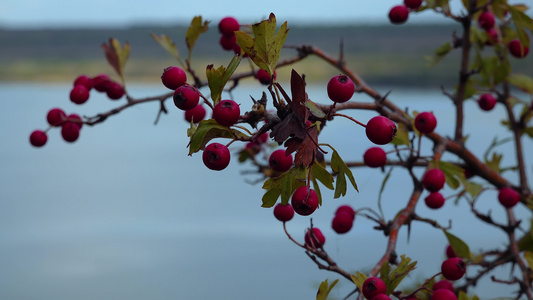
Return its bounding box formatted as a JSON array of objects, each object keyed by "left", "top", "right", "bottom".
[{"left": 30, "top": 0, "right": 533, "bottom": 299}]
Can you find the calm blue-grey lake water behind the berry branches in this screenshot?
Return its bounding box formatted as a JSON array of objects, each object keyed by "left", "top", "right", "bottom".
[{"left": 0, "top": 83, "right": 533, "bottom": 300}]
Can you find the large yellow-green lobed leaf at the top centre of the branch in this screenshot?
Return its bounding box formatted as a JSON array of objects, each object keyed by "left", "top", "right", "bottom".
[{"left": 235, "top": 13, "right": 289, "bottom": 76}]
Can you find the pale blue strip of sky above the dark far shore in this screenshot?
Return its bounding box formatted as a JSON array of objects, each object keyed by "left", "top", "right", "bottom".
[{"left": 0, "top": 0, "right": 530, "bottom": 28}]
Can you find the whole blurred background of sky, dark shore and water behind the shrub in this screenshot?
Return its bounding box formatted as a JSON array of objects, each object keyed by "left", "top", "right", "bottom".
[{"left": 0, "top": 0, "right": 533, "bottom": 299}]
